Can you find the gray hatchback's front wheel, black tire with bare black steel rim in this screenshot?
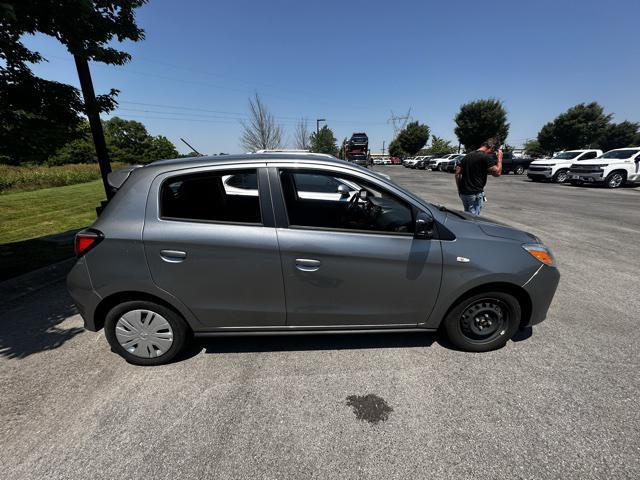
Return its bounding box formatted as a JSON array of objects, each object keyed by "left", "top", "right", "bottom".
[{"left": 443, "top": 291, "right": 522, "bottom": 352}]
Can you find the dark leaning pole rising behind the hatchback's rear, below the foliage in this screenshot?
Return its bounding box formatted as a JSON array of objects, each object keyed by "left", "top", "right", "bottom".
[{"left": 73, "top": 55, "right": 113, "bottom": 200}]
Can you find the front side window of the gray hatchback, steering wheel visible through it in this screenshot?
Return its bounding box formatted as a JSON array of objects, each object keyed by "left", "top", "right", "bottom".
[{"left": 280, "top": 169, "right": 414, "bottom": 234}]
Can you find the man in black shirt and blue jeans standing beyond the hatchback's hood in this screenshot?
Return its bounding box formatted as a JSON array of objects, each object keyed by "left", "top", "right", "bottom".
[{"left": 455, "top": 138, "right": 502, "bottom": 215}]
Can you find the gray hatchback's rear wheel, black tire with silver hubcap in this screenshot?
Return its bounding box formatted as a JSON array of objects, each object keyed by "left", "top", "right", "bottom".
[{"left": 104, "top": 301, "right": 190, "bottom": 365}]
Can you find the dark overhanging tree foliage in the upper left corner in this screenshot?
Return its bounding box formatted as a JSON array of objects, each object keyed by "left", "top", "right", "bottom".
[{"left": 0, "top": 0, "right": 145, "bottom": 163}]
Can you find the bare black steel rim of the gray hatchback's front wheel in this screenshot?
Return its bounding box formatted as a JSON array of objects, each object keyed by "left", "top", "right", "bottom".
[{"left": 460, "top": 298, "right": 509, "bottom": 343}]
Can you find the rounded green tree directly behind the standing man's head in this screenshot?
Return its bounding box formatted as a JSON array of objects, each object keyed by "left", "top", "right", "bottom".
[{"left": 454, "top": 98, "right": 509, "bottom": 151}]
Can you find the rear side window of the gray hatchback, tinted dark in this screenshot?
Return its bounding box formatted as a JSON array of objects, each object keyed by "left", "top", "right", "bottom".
[{"left": 160, "top": 169, "right": 262, "bottom": 224}]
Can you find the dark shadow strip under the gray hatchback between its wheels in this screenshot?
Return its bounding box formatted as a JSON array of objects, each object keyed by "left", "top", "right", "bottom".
[{"left": 176, "top": 332, "right": 437, "bottom": 361}]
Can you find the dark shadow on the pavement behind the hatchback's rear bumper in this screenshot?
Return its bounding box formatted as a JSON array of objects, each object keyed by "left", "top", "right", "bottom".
[{"left": 0, "top": 282, "right": 84, "bottom": 359}]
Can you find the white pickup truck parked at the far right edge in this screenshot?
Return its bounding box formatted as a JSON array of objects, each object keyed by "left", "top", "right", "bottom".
[{"left": 569, "top": 147, "right": 640, "bottom": 188}]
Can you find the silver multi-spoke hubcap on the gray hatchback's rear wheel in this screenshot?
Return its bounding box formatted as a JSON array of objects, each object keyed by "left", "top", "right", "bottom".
[{"left": 116, "top": 310, "right": 173, "bottom": 358}]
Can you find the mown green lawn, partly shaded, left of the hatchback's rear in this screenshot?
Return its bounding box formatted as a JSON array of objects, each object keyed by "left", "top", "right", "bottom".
[{"left": 0, "top": 180, "right": 105, "bottom": 281}]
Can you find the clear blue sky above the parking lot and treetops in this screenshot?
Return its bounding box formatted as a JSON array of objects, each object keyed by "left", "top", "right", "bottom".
[{"left": 26, "top": 0, "right": 640, "bottom": 153}]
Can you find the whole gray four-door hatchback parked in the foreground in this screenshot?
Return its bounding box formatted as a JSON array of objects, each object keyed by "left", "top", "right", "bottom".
[{"left": 68, "top": 153, "right": 560, "bottom": 365}]
